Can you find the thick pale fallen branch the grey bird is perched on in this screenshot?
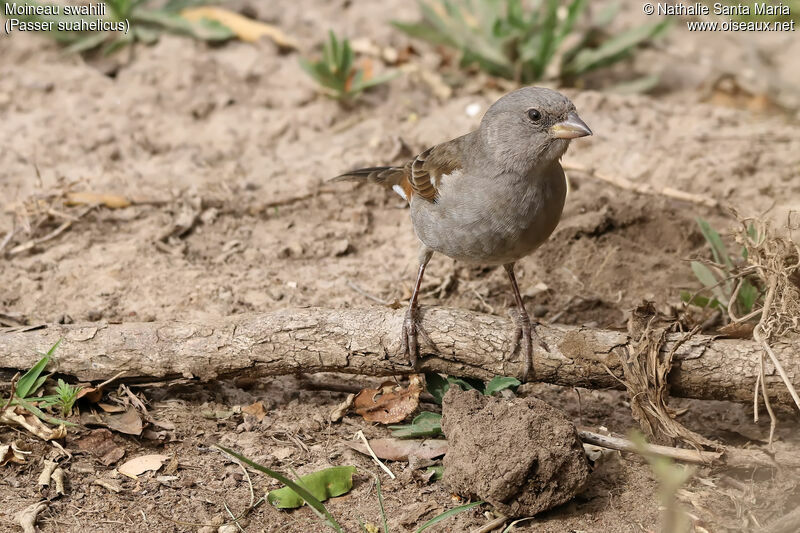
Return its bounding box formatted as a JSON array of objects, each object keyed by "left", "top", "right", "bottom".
[{"left": 0, "top": 307, "right": 800, "bottom": 407}]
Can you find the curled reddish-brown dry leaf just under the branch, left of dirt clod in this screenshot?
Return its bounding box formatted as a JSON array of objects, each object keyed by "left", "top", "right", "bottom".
[{"left": 353, "top": 375, "right": 422, "bottom": 424}]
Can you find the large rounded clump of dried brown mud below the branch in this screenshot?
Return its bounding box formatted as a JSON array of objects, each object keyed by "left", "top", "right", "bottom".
[{"left": 442, "top": 387, "right": 589, "bottom": 516}]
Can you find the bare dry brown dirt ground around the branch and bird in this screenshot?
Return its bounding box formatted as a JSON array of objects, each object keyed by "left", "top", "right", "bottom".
[{"left": 0, "top": 0, "right": 800, "bottom": 533}]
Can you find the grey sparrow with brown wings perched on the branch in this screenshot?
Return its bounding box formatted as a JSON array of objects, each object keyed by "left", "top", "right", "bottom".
[{"left": 332, "top": 87, "right": 592, "bottom": 381}]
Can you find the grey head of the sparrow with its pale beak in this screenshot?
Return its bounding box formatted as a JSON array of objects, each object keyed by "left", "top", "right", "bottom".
[{"left": 481, "top": 87, "right": 592, "bottom": 174}]
